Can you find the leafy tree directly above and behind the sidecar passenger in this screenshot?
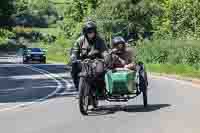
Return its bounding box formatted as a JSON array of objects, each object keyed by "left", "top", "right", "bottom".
[{"left": 90, "top": 0, "right": 158, "bottom": 40}]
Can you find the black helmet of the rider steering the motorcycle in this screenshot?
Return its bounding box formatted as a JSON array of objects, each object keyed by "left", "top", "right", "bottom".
[{"left": 83, "top": 21, "right": 97, "bottom": 34}]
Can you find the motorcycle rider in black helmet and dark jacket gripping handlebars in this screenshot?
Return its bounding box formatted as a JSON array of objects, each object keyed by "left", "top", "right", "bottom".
[{"left": 71, "top": 21, "right": 107, "bottom": 91}]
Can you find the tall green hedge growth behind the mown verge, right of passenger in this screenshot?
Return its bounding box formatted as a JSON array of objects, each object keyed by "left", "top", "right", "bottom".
[{"left": 137, "top": 40, "right": 200, "bottom": 67}]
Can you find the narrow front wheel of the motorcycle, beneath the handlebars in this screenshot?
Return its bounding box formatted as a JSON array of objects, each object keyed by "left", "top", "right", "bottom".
[{"left": 79, "top": 77, "right": 90, "bottom": 115}]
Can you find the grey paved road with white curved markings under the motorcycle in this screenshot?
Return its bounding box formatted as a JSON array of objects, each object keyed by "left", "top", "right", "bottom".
[{"left": 0, "top": 54, "right": 200, "bottom": 133}]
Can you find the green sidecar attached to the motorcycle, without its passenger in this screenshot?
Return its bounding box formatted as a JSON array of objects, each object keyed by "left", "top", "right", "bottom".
[{"left": 105, "top": 68, "right": 147, "bottom": 106}]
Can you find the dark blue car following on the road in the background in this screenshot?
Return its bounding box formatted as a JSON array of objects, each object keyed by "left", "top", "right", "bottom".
[{"left": 23, "top": 48, "right": 46, "bottom": 64}]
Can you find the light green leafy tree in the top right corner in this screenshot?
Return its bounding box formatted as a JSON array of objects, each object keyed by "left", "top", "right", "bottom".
[{"left": 154, "top": 0, "right": 200, "bottom": 39}]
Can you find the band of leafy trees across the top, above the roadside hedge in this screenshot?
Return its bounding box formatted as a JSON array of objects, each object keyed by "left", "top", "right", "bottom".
[{"left": 0, "top": 0, "right": 200, "bottom": 41}]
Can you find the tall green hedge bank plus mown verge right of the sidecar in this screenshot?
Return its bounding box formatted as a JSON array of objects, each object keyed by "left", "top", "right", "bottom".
[{"left": 137, "top": 40, "right": 200, "bottom": 78}]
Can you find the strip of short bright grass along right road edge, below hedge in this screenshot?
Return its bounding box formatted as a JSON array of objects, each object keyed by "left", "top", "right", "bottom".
[{"left": 146, "top": 64, "right": 200, "bottom": 78}]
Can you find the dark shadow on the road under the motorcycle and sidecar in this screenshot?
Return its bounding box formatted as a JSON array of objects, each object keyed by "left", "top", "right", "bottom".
[{"left": 89, "top": 104, "right": 171, "bottom": 116}]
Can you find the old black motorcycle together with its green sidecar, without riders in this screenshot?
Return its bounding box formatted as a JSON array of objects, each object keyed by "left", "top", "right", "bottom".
[{"left": 79, "top": 52, "right": 148, "bottom": 115}]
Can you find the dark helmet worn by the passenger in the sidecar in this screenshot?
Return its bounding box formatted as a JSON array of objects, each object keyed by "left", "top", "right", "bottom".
[{"left": 112, "top": 36, "right": 126, "bottom": 53}]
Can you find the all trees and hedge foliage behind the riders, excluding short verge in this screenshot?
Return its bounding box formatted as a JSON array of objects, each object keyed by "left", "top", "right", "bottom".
[{"left": 0, "top": 0, "right": 200, "bottom": 67}]
